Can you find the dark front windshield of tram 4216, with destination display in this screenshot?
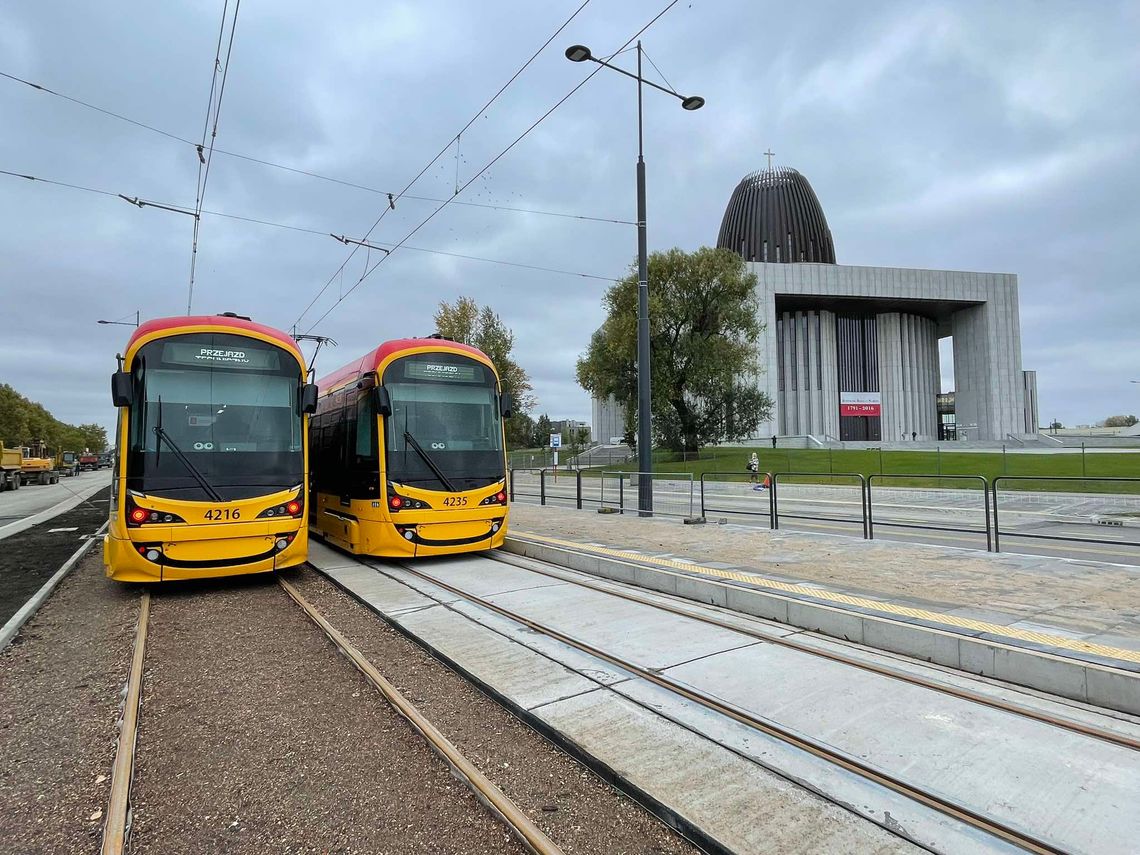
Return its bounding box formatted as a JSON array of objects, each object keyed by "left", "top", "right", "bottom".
[{"left": 127, "top": 333, "right": 304, "bottom": 500}]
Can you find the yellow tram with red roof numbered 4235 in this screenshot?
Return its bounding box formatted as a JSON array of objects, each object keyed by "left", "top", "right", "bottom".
[{"left": 309, "top": 336, "right": 512, "bottom": 557}]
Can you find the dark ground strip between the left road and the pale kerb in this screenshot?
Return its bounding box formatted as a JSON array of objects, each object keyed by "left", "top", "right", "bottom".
[{"left": 0, "top": 487, "right": 111, "bottom": 626}]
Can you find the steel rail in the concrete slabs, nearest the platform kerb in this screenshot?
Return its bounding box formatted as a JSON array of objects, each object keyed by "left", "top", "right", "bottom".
[{"left": 483, "top": 547, "right": 1140, "bottom": 751}]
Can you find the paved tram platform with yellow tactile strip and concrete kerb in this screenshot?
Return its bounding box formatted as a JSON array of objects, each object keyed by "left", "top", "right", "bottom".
[{"left": 506, "top": 504, "right": 1140, "bottom": 715}]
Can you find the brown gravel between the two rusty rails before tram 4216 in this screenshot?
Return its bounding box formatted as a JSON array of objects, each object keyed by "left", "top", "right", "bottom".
[{"left": 131, "top": 577, "right": 522, "bottom": 855}]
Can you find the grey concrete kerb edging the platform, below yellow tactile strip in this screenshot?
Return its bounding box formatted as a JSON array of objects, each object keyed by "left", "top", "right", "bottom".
[{"left": 503, "top": 535, "right": 1140, "bottom": 715}]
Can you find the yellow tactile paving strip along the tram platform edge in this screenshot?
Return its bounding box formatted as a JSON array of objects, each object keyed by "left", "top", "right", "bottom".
[{"left": 511, "top": 529, "right": 1140, "bottom": 663}]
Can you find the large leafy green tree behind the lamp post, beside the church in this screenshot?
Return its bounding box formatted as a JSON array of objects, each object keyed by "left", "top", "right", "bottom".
[{"left": 578, "top": 246, "right": 772, "bottom": 451}]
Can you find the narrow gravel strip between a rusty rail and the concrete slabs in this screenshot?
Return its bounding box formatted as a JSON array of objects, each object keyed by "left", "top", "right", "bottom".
[{"left": 288, "top": 568, "right": 695, "bottom": 855}]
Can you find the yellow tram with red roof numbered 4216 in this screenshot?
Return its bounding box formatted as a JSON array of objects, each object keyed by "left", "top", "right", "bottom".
[{"left": 103, "top": 312, "right": 317, "bottom": 581}]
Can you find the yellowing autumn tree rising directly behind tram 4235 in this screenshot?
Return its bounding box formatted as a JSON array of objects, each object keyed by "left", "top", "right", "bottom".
[{"left": 435, "top": 296, "right": 538, "bottom": 448}]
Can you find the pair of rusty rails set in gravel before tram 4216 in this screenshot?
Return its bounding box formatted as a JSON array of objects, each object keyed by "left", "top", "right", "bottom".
[{"left": 99, "top": 577, "right": 562, "bottom": 855}]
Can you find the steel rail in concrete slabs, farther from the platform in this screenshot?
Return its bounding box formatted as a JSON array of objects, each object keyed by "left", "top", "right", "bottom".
[{"left": 389, "top": 562, "right": 1065, "bottom": 855}]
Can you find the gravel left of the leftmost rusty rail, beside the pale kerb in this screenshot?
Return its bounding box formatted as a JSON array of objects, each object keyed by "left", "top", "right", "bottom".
[{"left": 0, "top": 551, "right": 139, "bottom": 855}]
